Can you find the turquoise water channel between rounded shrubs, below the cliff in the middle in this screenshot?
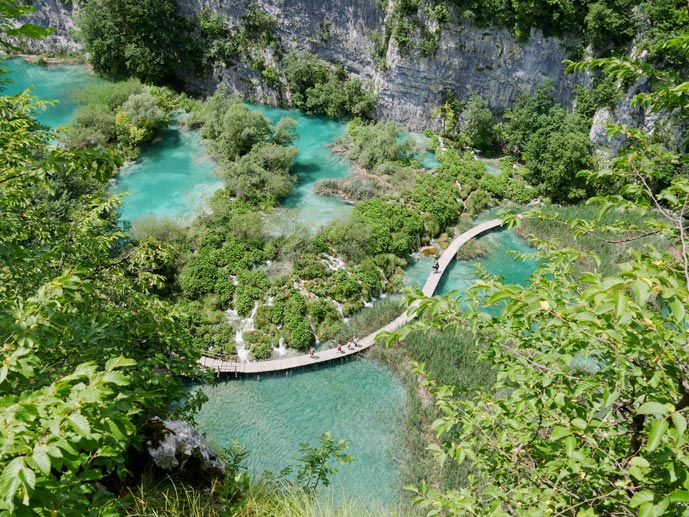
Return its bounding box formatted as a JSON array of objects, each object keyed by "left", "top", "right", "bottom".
[{"left": 250, "top": 104, "right": 352, "bottom": 233}]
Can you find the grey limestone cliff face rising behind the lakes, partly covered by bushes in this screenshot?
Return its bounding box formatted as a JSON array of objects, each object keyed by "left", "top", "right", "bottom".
[{"left": 21, "top": 0, "right": 576, "bottom": 130}]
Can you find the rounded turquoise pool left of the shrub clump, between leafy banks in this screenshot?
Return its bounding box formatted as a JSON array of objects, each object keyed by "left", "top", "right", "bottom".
[{"left": 111, "top": 128, "right": 222, "bottom": 224}]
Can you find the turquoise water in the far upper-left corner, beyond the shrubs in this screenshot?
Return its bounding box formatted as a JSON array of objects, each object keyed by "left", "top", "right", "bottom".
[{"left": 2, "top": 59, "right": 103, "bottom": 128}]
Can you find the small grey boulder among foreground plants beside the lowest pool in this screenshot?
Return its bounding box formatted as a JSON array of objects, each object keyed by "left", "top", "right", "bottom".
[{"left": 146, "top": 417, "right": 226, "bottom": 480}]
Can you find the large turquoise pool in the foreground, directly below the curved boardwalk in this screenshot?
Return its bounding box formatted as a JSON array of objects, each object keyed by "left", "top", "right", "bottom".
[{"left": 197, "top": 359, "right": 406, "bottom": 507}]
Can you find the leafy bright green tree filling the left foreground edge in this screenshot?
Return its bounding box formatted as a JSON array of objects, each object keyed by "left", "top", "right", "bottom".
[{"left": 0, "top": 88, "right": 204, "bottom": 515}]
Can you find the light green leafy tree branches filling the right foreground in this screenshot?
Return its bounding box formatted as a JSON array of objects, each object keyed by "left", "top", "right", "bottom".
[{"left": 384, "top": 30, "right": 689, "bottom": 516}]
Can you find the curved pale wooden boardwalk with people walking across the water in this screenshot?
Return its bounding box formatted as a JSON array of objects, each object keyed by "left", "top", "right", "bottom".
[{"left": 199, "top": 219, "right": 502, "bottom": 375}]
